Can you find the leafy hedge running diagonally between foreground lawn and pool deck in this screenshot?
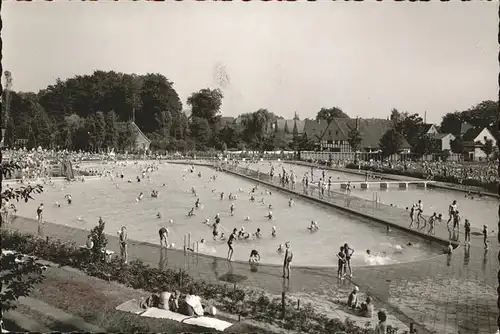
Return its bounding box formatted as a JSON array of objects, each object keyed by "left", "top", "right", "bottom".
[{"left": 0, "top": 229, "right": 406, "bottom": 334}]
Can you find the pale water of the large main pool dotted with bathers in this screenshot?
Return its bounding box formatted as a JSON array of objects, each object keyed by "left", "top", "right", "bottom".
[{"left": 10, "top": 163, "right": 439, "bottom": 266}]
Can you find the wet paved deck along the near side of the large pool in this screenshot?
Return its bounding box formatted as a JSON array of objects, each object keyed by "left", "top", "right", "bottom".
[{"left": 4, "top": 160, "right": 498, "bottom": 333}]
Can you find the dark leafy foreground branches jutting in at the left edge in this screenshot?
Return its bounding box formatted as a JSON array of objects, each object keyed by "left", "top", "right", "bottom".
[{"left": 0, "top": 162, "right": 46, "bottom": 315}]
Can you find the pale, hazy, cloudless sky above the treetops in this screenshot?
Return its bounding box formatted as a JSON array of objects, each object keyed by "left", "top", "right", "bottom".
[{"left": 1, "top": 0, "right": 499, "bottom": 123}]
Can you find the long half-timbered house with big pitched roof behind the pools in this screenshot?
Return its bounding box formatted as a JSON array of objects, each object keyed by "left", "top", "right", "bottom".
[{"left": 304, "top": 118, "right": 410, "bottom": 152}]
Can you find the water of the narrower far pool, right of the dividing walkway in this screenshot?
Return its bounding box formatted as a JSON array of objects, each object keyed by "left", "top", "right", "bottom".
[{"left": 240, "top": 162, "right": 498, "bottom": 229}]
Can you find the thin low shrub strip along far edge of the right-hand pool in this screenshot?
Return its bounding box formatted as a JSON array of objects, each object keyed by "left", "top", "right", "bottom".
[{"left": 346, "top": 163, "right": 500, "bottom": 195}]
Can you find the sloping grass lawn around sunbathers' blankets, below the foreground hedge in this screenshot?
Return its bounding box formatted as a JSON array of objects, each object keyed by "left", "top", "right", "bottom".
[{"left": 27, "top": 267, "right": 280, "bottom": 333}]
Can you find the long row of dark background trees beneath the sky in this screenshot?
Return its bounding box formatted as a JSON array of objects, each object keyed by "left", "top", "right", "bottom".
[{"left": 2, "top": 71, "right": 498, "bottom": 155}]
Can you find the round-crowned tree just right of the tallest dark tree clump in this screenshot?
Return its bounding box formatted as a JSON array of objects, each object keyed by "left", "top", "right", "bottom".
[{"left": 187, "top": 88, "right": 224, "bottom": 125}]
